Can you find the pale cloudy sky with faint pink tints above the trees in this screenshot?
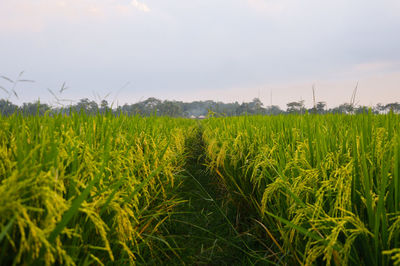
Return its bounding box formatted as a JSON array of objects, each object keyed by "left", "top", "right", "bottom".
[{"left": 0, "top": 0, "right": 400, "bottom": 107}]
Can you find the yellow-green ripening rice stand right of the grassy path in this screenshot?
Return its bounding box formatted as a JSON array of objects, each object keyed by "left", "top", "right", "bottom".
[{"left": 203, "top": 113, "right": 400, "bottom": 265}]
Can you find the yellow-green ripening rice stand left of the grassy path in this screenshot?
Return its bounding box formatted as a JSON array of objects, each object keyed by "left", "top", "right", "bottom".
[{"left": 0, "top": 113, "right": 194, "bottom": 265}]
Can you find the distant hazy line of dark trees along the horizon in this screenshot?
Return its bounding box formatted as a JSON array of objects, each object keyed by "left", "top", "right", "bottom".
[{"left": 0, "top": 98, "right": 400, "bottom": 118}]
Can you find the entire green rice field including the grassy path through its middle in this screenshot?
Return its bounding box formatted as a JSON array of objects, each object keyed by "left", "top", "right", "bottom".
[{"left": 0, "top": 113, "right": 400, "bottom": 265}]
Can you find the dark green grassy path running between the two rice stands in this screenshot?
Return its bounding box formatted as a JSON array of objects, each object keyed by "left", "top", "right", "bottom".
[{"left": 164, "top": 126, "right": 266, "bottom": 265}]
